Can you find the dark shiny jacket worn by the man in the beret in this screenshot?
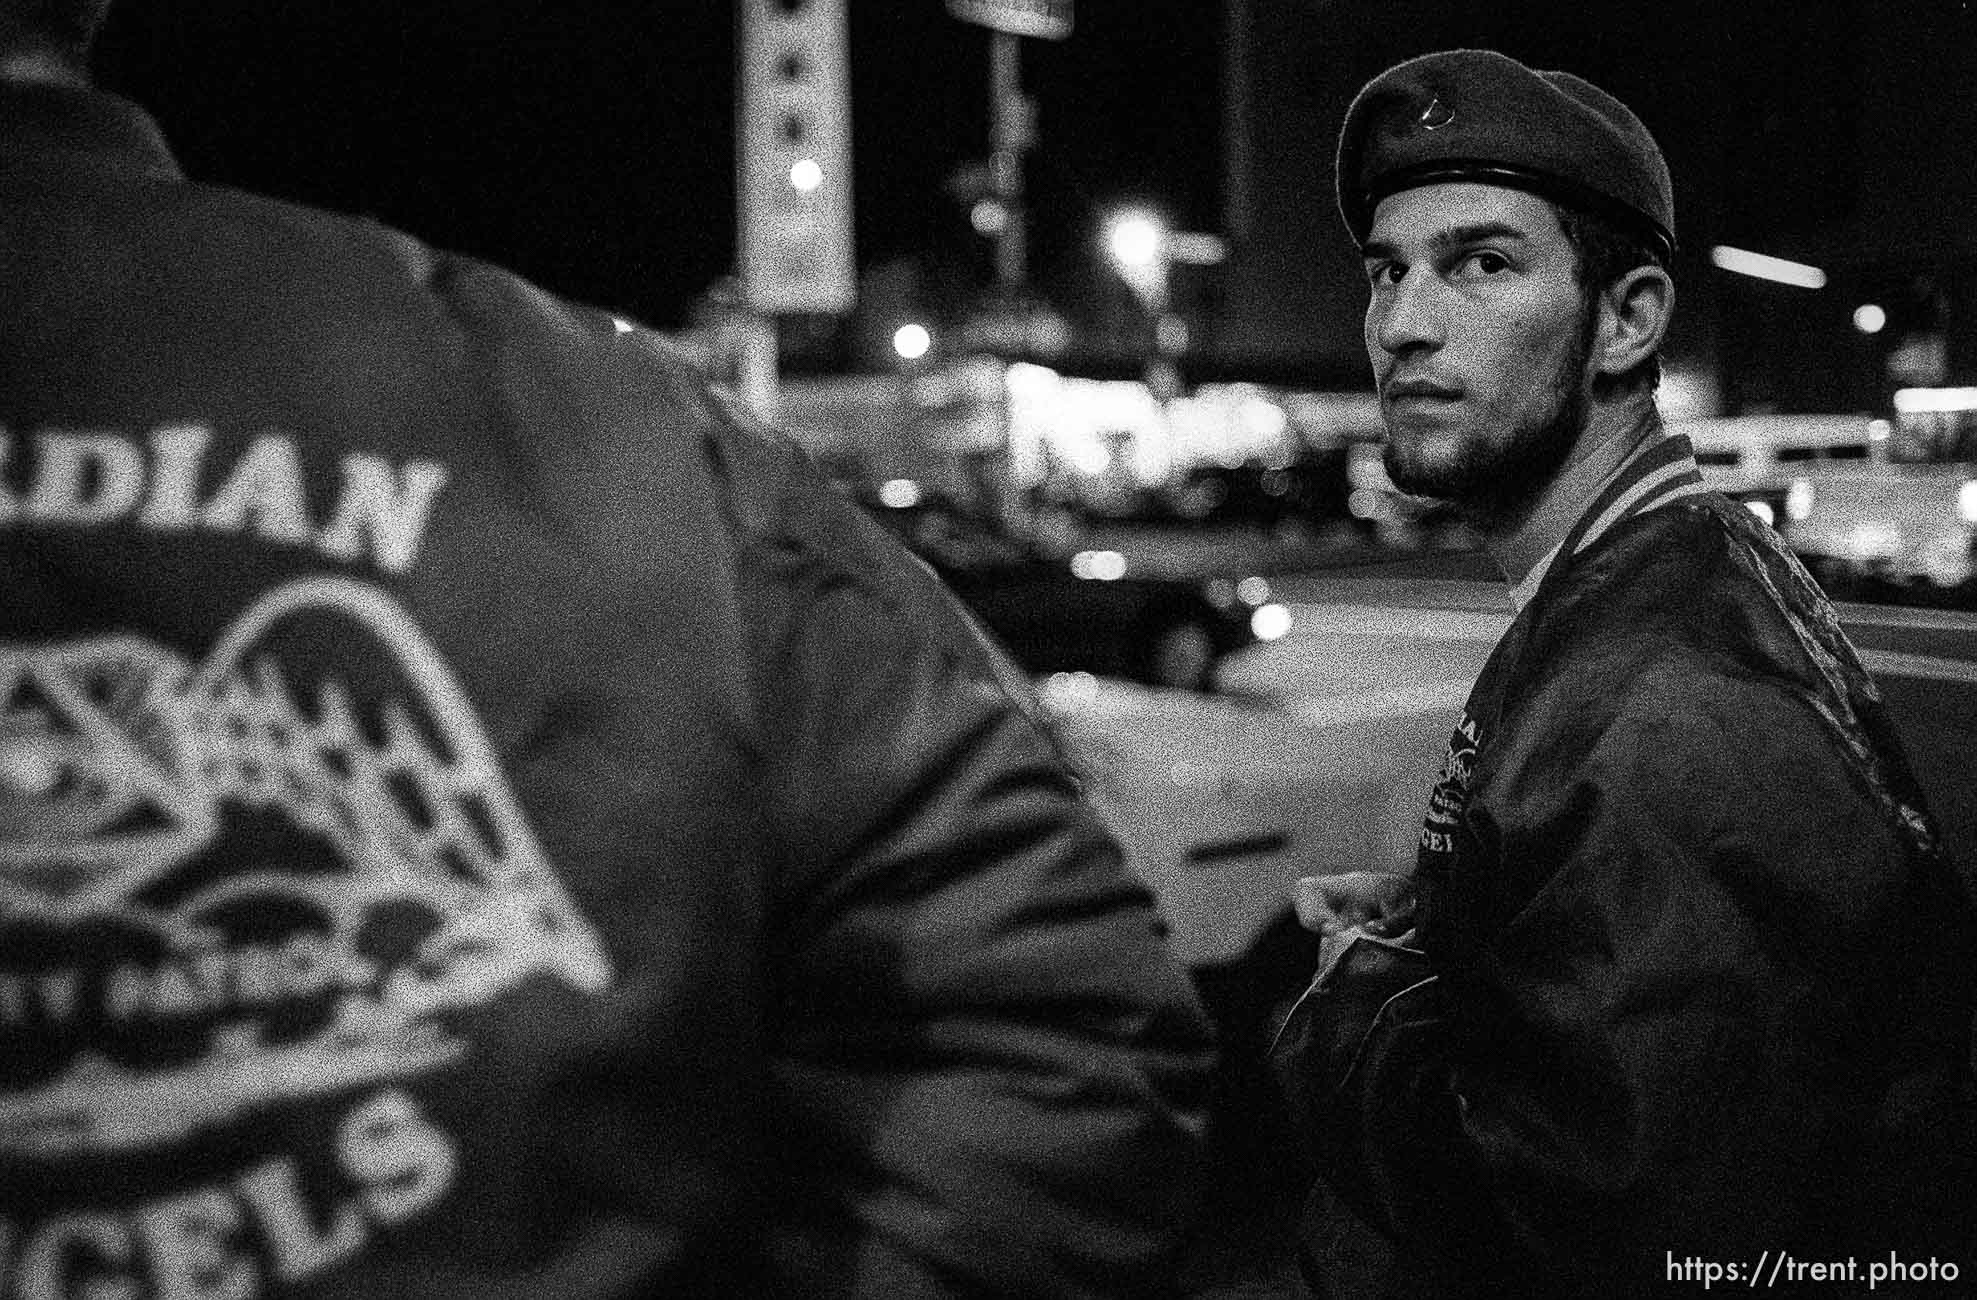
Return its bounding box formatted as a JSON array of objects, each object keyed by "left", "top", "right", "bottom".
[{"left": 1277, "top": 470, "right": 1977, "bottom": 1296}]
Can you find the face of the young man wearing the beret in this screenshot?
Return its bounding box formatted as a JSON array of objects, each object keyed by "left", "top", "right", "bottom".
[{"left": 1364, "top": 182, "right": 1591, "bottom": 510}]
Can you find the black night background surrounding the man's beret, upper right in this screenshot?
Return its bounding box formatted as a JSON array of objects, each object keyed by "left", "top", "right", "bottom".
[{"left": 1228, "top": 0, "right": 1977, "bottom": 385}]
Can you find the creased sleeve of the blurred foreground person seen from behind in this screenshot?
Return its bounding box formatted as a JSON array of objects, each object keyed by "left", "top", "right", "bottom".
[{"left": 741, "top": 432, "right": 1212, "bottom": 1296}]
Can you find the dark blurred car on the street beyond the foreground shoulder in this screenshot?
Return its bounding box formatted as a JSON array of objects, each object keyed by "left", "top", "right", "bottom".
[{"left": 856, "top": 482, "right": 1287, "bottom": 690}]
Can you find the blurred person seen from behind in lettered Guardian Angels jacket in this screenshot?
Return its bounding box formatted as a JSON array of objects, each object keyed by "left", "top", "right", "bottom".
[{"left": 0, "top": 0, "right": 1210, "bottom": 1300}]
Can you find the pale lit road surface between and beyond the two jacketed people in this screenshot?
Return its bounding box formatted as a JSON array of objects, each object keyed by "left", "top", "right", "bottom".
[{"left": 1048, "top": 555, "right": 1977, "bottom": 966}]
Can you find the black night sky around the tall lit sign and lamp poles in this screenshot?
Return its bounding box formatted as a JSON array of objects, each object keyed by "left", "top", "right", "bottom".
[{"left": 97, "top": 0, "right": 1220, "bottom": 333}]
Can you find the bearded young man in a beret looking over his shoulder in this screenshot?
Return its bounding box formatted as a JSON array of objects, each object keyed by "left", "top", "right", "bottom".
[{"left": 1283, "top": 49, "right": 1977, "bottom": 1296}]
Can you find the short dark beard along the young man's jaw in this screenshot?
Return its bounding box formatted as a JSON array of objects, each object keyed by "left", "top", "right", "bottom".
[{"left": 1382, "top": 304, "right": 1599, "bottom": 524}]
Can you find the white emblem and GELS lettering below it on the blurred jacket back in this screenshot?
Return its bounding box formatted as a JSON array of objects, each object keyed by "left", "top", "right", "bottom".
[{"left": 0, "top": 579, "right": 613, "bottom": 1296}]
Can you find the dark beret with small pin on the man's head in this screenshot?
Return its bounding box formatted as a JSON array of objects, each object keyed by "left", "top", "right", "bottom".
[{"left": 1338, "top": 49, "right": 1675, "bottom": 257}]
